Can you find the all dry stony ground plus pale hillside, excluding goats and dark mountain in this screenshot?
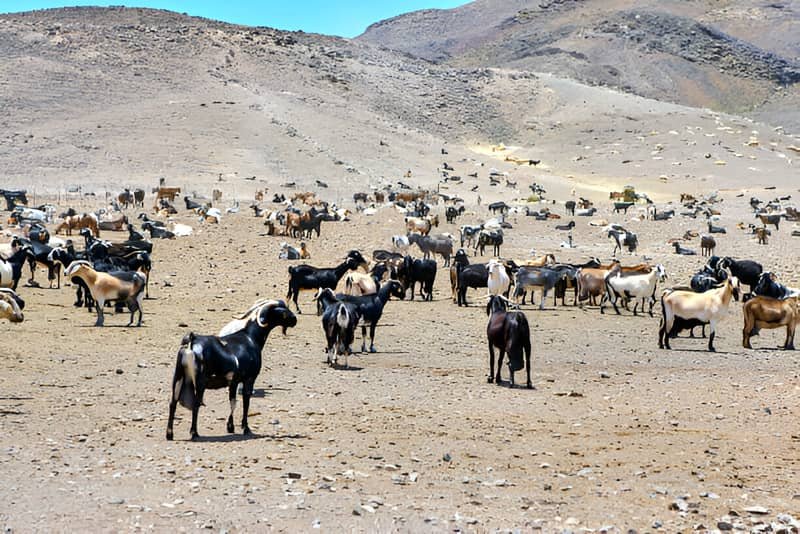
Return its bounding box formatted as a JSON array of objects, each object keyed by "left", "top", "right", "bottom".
[{"left": 0, "top": 2, "right": 800, "bottom": 532}]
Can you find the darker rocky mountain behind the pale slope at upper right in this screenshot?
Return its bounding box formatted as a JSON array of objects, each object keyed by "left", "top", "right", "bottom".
[{"left": 359, "top": 0, "right": 800, "bottom": 112}]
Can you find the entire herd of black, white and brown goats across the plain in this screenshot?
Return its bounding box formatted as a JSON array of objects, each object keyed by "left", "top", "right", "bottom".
[{"left": 0, "top": 183, "right": 800, "bottom": 439}]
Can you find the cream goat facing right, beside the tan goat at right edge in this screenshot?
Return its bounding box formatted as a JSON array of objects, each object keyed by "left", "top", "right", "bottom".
[{"left": 658, "top": 276, "right": 740, "bottom": 352}]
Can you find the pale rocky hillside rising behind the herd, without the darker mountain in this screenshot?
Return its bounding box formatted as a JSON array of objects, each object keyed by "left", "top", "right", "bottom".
[{"left": 0, "top": 8, "right": 800, "bottom": 199}]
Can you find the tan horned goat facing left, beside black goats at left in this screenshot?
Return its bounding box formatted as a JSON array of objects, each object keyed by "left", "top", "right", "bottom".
[{"left": 64, "top": 260, "right": 147, "bottom": 326}]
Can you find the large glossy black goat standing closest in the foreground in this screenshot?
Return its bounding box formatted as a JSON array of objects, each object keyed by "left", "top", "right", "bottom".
[{"left": 167, "top": 301, "right": 297, "bottom": 441}]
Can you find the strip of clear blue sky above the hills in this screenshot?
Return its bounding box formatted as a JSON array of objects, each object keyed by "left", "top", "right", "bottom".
[{"left": 0, "top": 0, "right": 466, "bottom": 37}]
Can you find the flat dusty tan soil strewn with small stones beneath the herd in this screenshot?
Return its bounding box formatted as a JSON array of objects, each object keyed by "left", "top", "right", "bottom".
[{"left": 0, "top": 187, "right": 800, "bottom": 532}]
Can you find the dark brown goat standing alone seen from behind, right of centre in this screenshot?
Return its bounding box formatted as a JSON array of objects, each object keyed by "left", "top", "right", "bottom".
[{"left": 486, "top": 295, "right": 533, "bottom": 389}]
